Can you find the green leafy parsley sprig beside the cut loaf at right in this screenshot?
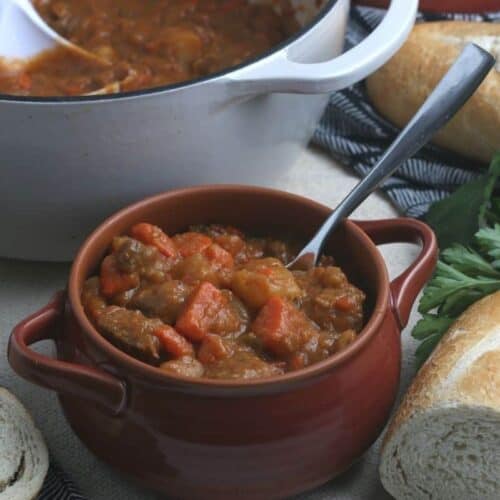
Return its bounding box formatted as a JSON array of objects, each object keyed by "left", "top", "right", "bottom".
[{"left": 412, "top": 154, "right": 500, "bottom": 365}]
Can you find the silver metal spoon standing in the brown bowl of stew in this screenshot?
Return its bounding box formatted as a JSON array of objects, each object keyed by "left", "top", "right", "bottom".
[{"left": 287, "top": 43, "right": 495, "bottom": 269}]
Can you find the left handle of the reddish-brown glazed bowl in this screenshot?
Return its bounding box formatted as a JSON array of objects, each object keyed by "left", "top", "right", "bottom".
[{"left": 7, "top": 292, "right": 126, "bottom": 415}]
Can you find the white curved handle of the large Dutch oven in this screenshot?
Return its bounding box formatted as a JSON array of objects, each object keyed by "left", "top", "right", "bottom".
[{"left": 228, "top": 0, "right": 418, "bottom": 95}]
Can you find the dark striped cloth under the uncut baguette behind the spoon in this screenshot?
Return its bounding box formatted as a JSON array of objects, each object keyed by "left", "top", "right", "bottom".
[{"left": 313, "top": 7, "right": 500, "bottom": 217}]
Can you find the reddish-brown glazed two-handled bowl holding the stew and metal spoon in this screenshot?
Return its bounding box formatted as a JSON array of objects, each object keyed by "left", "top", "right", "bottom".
[{"left": 8, "top": 186, "right": 437, "bottom": 499}]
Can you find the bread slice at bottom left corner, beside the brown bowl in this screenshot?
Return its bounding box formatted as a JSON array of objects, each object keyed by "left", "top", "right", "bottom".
[{"left": 0, "top": 388, "right": 49, "bottom": 500}]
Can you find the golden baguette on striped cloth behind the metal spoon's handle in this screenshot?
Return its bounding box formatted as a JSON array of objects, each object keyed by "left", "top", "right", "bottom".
[{"left": 366, "top": 21, "right": 500, "bottom": 162}]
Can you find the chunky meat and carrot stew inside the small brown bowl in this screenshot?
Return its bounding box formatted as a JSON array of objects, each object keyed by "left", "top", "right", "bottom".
[{"left": 82, "top": 223, "right": 365, "bottom": 379}]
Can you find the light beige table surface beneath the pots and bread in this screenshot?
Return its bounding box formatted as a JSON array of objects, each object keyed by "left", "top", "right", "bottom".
[{"left": 0, "top": 148, "right": 417, "bottom": 500}]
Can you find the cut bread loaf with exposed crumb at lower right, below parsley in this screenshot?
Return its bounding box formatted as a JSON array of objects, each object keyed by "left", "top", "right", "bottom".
[{"left": 380, "top": 292, "right": 500, "bottom": 500}]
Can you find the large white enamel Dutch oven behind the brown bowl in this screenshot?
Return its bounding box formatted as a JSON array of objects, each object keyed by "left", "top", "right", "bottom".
[{"left": 0, "top": 0, "right": 418, "bottom": 260}]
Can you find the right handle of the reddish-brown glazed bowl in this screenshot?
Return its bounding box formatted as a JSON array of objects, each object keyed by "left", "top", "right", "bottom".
[{"left": 356, "top": 217, "right": 438, "bottom": 328}]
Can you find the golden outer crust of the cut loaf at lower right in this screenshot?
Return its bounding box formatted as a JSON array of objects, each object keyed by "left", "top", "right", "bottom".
[{"left": 382, "top": 292, "right": 500, "bottom": 448}]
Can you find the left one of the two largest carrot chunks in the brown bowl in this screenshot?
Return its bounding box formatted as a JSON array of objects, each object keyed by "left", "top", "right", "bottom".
[{"left": 175, "top": 281, "right": 227, "bottom": 340}]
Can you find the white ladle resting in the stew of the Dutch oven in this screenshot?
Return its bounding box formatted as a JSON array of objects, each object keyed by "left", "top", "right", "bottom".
[{"left": 0, "top": 0, "right": 109, "bottom": 65}]
